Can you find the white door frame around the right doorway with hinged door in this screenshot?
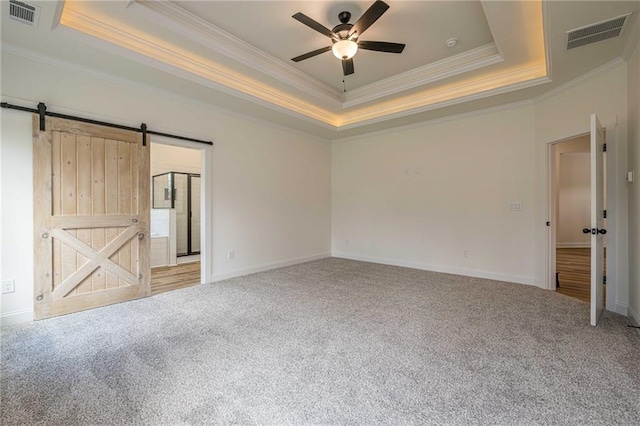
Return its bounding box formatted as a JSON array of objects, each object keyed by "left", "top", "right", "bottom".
[{"left": 543, "top": 126, "right": 626, "bottom": 315}]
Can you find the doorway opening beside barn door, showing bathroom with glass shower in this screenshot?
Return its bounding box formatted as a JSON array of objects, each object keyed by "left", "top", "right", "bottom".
[{"left": 150, "top": 140, "right": 206, "bottom": 295}]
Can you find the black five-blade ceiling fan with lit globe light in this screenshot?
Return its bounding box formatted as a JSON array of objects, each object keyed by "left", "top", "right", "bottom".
[{"left": 291, "top": 0, "right": 405, "bottom": 75}]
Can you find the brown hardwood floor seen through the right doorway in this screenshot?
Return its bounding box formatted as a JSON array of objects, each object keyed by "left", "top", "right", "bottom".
[{"left": 556, "top": 248, "right": 606, "bottom": 302}]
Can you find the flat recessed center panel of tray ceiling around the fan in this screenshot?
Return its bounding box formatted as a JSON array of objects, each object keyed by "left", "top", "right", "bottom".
[{"left": 175, "top": 1, "right": 493, "bottom": 91}]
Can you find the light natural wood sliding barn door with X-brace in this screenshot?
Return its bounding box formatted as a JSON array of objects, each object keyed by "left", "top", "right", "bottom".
[{"left": 33, "top": 116, "right": 150, "bottom": 319}]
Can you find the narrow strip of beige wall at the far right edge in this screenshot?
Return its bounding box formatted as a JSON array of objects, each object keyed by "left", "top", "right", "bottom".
[{"left": 628, "top": 39, "right": 640, "bottom": 325}]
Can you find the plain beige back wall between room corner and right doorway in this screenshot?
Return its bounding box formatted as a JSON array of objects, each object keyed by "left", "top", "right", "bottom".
[{"left": 333, "top": 103, "right": 536, "bottom": 284}]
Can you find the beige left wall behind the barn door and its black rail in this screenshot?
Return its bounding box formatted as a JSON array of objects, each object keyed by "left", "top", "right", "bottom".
[{"left": 1, "top": 52, "right": 331, "bottom": 322}]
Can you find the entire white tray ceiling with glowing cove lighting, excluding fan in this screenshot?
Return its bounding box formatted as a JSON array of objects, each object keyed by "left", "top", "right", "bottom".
[{"left": 1, "top": 0, "right": 640, "bottom": 139}]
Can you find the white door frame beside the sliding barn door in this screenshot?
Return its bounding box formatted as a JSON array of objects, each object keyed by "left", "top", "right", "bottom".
[{"left": 149, "top": 135, "right": 213, "bottom": 284}]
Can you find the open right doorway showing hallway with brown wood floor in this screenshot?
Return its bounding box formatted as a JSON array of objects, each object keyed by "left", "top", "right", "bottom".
[{"left": 549, "top": 134, "right": 606, "bottom": 303}]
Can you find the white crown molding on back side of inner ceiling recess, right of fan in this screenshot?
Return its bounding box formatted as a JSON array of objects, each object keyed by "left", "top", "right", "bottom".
[{"left": 343, "top": 43, "right": 504, "bottom": 108}]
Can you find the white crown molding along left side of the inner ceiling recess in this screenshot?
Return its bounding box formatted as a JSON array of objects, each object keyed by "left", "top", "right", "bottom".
[{"left": 129, "top": 0, "right": 342, "bottom": 108}]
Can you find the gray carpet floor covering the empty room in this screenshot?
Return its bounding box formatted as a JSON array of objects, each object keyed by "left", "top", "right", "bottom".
[{"left": 0, "top": 259, "right": 640, "bottom": 425}]
